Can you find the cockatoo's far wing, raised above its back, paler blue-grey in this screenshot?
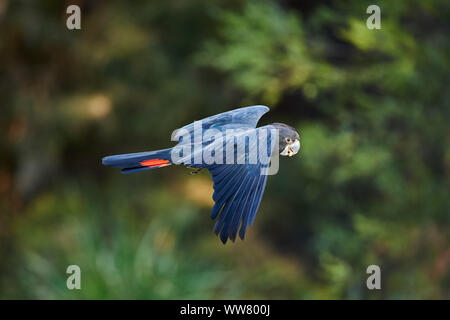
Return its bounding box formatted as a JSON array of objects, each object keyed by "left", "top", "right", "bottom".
[{"left": 174, "top": 106, "right": 269, "bottom": 143}]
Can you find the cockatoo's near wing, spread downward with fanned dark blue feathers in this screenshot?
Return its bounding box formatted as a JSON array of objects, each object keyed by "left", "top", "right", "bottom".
[{"left": 206, "top": 126, "right": 275, "bottom": 243}]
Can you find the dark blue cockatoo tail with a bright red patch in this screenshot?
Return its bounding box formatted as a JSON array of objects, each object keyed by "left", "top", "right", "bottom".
[{"left": 102, "top": 148, "right": 172, "bottom": 173}]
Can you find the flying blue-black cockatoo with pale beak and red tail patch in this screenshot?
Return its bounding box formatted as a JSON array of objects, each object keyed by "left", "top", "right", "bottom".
[{"left": 102, "top": 105, "right": 300, "bottom": 244}]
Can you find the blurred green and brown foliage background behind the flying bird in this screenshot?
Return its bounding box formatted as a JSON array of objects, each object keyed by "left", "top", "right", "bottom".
[{"left": 0, "top": 0, "right": 450, "bottom": 299}]
